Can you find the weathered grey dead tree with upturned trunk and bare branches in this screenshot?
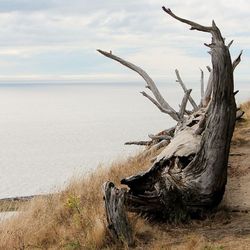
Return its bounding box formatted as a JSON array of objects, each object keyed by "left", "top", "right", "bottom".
[{"left": 98, "top": 7, "right": 241, "bottom": 244}]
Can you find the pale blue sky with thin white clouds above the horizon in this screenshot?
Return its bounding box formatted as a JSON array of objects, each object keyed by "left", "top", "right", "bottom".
[{"left": 0, "top": 0, "right": 250, "bottom": 83}]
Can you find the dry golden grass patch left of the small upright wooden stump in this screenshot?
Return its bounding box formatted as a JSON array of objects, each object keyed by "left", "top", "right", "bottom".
[{"left": 0, "top": 151, "right": 155, "bottom": 250}]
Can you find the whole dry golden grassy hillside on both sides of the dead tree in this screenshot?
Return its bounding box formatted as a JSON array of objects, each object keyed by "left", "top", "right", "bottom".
[{"left": 0, "top": 102, "right": 250, "bottom": 250}]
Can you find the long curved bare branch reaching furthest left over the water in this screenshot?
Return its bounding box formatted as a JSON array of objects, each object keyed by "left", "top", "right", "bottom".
[{"left": 97, "top": 49, "right": 178, "bottom": 120}]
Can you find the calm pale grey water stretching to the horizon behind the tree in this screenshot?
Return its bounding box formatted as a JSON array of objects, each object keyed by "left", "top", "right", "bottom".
[{"left": 0, "top": 83, "right": 250, "bottom": 198}]
